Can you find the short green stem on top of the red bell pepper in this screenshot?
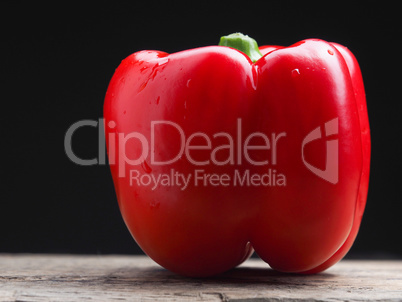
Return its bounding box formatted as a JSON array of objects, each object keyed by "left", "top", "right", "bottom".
[{"left": 219, "top": 33, "right": 262, "bottom": 63}]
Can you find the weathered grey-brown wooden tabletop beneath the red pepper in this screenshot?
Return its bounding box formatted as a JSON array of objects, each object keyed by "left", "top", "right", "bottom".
[{"left": 0, "top": 254, "right": 402, "bottom": 302}]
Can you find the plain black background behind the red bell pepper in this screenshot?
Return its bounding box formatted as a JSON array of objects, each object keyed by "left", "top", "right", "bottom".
[{"left": 0, "top": 1, "right": 402, "bottom": 258}]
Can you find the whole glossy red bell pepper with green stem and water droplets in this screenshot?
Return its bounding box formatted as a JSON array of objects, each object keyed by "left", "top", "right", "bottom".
[{"left": 104, "top": 34, "right": 370, "bottom": 276}]
